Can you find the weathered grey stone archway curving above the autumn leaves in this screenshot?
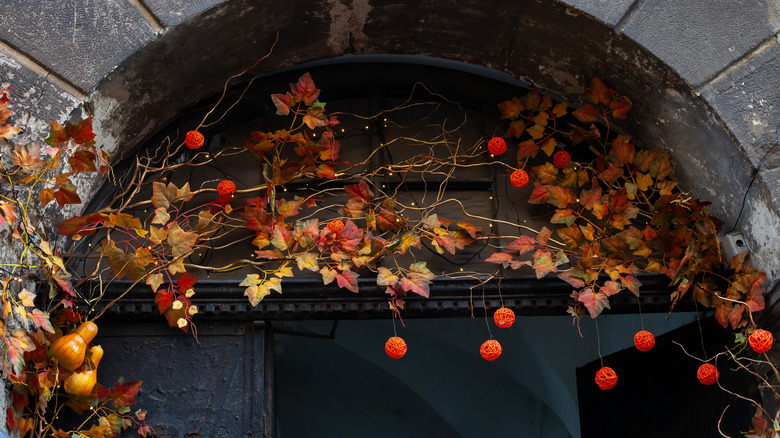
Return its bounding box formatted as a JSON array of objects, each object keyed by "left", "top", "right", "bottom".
[{"left": 0, "top": 0, "right": 780, "bottom": 279}]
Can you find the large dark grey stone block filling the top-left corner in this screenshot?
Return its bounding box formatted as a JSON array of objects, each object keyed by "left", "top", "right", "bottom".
[{"left": 0, "top": 0, "right": 154, "bottom": 91}]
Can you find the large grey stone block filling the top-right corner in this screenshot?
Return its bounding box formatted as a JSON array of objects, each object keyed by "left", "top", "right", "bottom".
[{"left": 623, "top": 0, "right": 780, "bottom": 86}]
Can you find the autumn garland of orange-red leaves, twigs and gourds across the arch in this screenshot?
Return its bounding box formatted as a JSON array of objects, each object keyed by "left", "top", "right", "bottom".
[{"left": 0, "top": 73, "right": 773, "bottom": 437}]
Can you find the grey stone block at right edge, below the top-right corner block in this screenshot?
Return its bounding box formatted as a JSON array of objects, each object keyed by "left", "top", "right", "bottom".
[{"left": 701, "top": 43, "right": 780, "bottom": 170}]
